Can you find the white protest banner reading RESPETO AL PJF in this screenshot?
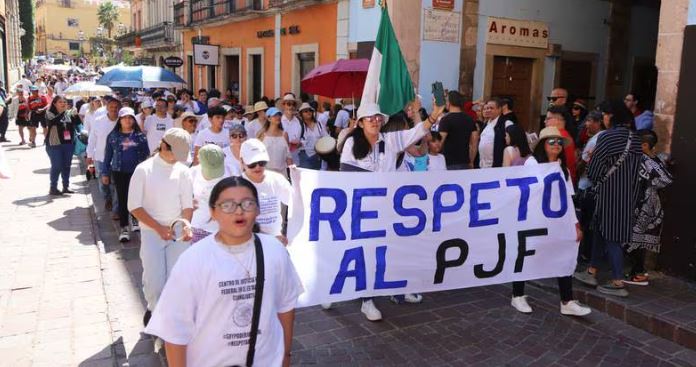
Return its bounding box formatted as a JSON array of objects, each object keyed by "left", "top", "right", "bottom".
[{"left": 288, "top": 164, "right": 577, "bottom": 306}]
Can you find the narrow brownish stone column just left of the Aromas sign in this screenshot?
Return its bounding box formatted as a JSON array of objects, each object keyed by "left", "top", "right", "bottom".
[{"left": 459, "top": 0, "right": 483, "bottom": 100}]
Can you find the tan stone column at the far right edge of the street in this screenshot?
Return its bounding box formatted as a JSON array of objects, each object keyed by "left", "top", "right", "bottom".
[{"left": 654, "top": 0, "right": 689, "bottom": 152}]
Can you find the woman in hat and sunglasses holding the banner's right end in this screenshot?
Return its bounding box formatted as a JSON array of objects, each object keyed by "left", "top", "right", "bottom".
[{"left": 511, "top": 127, "right": 592, "bottom": 316}]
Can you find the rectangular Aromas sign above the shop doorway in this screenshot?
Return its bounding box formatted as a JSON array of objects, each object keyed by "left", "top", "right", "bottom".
[{"left": 487, "top": 17, "right": 549, "bottom": 48}]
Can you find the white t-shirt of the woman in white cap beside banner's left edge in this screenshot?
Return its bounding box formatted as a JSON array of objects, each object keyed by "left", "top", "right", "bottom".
[{"left": 242, "top": 170, "right": 292, "bottom": 236}]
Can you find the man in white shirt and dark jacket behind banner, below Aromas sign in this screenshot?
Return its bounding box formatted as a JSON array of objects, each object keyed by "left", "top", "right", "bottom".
[{"left": 479, "top": 98, "right": 513, "bottom": 168}]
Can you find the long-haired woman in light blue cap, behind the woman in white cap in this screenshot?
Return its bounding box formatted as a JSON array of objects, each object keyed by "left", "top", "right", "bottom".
[{"left": 258, "top": 107, "right": 293, "bottom": 177}]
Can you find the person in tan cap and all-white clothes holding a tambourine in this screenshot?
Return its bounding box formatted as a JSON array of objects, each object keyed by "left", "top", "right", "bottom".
[{"left": 128, "top": 128, "right": 193, "bottom": 326}]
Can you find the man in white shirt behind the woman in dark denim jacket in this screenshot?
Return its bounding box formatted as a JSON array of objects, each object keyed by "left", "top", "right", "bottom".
[{"left": 87, "top": 98, "right": 125, "bottom": 219}]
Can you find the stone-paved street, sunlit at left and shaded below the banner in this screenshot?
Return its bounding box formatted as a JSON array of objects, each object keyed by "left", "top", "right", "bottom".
[{"left": 0, "top": 127, "right": 696, "bottom": 367}]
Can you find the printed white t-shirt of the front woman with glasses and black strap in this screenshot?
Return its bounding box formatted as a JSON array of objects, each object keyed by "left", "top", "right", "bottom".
[{"left": 145, "top": 234, "right": 304, "bottom": 367}]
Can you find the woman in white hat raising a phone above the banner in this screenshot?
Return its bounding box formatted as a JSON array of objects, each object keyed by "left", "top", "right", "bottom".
[{"left": 334, "top": 103, "right": 444, "bottom": 321}]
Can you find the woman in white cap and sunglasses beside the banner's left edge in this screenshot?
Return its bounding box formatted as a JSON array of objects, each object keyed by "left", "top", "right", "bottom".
[{"left": 240, "top": 139, "right": 292, "bottom": 245}]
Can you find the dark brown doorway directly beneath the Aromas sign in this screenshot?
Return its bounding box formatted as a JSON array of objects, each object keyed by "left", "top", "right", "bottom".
[{"left": 491, "top": 56, "right": 534, "bottom": 131}]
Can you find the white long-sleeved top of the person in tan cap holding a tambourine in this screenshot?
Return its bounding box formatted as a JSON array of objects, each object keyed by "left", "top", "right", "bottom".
[{"left": 128, "top": 154, "right": 193, "bottom": 230}]
